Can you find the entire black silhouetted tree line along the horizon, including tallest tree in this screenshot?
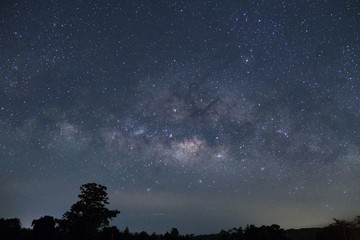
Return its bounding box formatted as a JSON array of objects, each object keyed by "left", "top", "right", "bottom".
[{"left": 0, "top": 183, "right": 360, "bottom": 240}]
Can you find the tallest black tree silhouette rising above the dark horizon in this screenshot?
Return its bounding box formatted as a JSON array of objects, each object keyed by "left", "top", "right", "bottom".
[{"left": 58, "top": 183, "right": 120, "bottom": 240}]
